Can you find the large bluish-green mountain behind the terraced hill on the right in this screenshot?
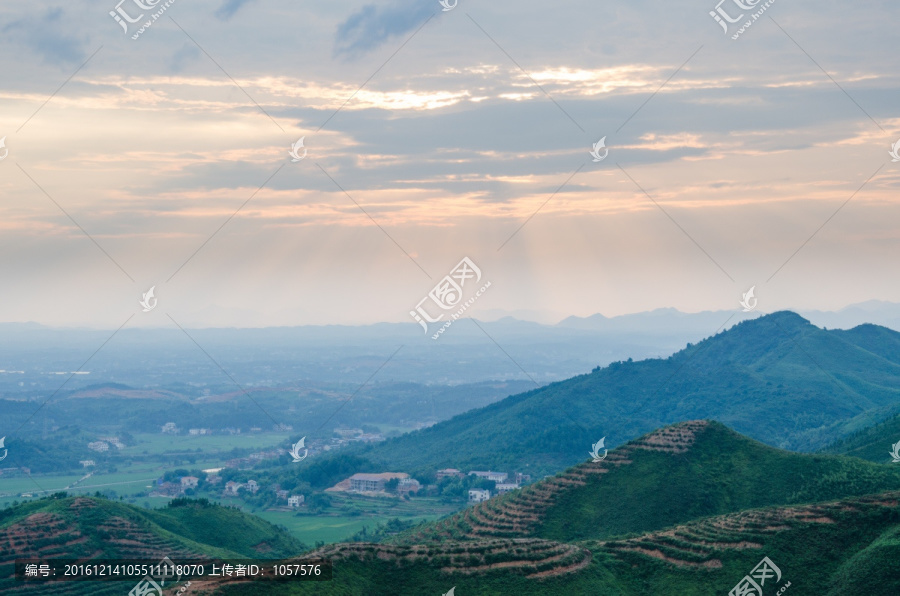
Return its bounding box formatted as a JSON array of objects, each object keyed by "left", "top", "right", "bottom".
[{"left": 348, "top": 312, "right": 900, "bottom": 475}]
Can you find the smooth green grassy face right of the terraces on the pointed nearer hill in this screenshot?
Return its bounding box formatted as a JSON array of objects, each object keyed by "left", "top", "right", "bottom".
[{"left": 536, "top": 423, "right": 900, "bottom": 541}]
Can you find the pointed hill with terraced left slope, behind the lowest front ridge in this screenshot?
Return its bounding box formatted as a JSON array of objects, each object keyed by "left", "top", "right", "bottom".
[{"left": 397, "top": 421, "right": 900, "bottom": 544}]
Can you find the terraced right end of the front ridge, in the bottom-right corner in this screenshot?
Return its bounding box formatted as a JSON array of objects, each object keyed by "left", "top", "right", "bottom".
[{"left": 581, "top": 492, "right": 900, "bottom": 596}]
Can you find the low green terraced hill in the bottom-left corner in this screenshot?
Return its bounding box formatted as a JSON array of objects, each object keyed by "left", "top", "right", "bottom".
[{"left": 0, "top": 493, "right": 307, "bottom": 594}]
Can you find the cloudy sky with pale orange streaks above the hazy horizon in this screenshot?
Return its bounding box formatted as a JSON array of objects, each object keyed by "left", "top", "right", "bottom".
[{"left": 0, "top": 0, "right": 900, "bottom": 329}]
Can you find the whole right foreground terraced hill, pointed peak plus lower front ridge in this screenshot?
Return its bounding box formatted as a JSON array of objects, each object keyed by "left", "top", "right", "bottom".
[{"left": 204, "top": 421, "right": 900, "bottom": 596}]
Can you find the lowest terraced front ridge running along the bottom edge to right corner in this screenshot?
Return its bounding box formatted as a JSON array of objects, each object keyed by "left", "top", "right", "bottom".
[{"left": 203, "top": 492, "right": 900, "bottom": 596}]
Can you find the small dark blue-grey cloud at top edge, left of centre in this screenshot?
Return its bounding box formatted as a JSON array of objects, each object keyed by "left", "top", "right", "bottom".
[{"left": 334, "top": 0, "right": 434, "bottom": 58}]
